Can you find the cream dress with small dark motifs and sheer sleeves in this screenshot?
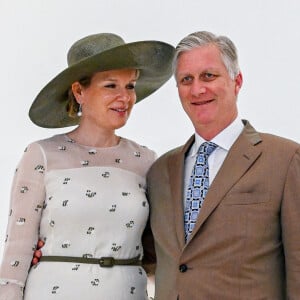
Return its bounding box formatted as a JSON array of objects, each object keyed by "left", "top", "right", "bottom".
[{"left": 0, "top": 134, "right": 155, "bottom": 300}]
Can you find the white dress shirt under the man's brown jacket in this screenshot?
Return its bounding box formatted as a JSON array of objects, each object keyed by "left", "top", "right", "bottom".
[{"left": 183, "top": 117, "right": 244, "bottom": 208}]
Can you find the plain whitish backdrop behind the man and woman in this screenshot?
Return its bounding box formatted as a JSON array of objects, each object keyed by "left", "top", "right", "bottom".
[{"left": 0, "top": 0, "right": 300, "bottom": 292}]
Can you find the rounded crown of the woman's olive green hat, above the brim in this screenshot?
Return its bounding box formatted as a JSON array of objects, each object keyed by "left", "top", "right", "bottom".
[{"left": 67, "top": 33, "right": 125, "bottom": 66}]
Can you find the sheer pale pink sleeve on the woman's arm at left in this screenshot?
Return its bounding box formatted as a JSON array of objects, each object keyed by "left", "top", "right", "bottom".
[{"left": 0, "top": 143, "right": 46, "bottom": 300}]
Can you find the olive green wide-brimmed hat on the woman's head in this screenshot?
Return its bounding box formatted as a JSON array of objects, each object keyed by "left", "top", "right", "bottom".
[{"left": 29, "top": 33, "right": 174, "bottom": 128}]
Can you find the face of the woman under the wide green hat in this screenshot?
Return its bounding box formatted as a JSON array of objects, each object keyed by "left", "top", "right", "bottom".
[{"left": 72, "top": 69, "right": 138, "bottom": 130}]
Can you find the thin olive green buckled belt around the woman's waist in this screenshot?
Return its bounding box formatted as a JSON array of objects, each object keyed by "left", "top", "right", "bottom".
[{"left": 40, "top": 255, "right": 142, "bottom": 268}]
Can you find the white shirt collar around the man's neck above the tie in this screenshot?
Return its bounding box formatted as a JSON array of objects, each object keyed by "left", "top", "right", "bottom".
[{"left": 190, "top": 117, "right": 244, "bottom": 156}]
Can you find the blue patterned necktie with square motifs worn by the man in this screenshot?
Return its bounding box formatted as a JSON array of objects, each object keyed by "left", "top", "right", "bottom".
[{"left": 184, "top": 142, "right": 217, "bottom": 241}]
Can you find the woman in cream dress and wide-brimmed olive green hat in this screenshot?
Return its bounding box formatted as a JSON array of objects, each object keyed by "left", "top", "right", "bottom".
[{"left": 0, "top": 33, "right": 174, "bottom": 300}]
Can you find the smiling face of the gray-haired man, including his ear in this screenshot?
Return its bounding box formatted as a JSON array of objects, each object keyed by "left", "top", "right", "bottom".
[{"left": 175, "top": 44, "right": 242, "bottom": 139}]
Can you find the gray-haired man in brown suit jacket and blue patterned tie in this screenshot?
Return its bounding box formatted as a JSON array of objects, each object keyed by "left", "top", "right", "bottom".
[{"left": 148, "top": 31, "right": 300, "bottom": 300}]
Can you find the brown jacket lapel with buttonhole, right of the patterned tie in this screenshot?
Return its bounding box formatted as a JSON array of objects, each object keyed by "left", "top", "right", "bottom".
[{"left": 182, "top": 122, "right": 261, "bottom": 243}]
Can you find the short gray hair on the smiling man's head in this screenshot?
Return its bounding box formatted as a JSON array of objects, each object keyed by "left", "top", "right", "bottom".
[{"left": 173, "top": 31, "right": 240, "bottom": 79}]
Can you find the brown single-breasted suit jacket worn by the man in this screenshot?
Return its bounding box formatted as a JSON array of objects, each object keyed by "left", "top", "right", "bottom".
[{"left": 146, "top": 122, "right": 300, "bottom": 300}]
